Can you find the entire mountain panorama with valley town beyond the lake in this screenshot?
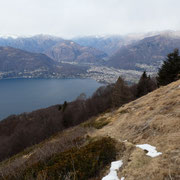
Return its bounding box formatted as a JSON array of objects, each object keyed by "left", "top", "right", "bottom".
[{"left": 0, "top": 31, "right": 180, "bottom": 82}]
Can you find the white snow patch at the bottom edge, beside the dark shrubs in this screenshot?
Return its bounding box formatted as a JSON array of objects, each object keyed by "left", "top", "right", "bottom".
[{"left": 102, "top": 160, "right": 124, "bottom": 180}]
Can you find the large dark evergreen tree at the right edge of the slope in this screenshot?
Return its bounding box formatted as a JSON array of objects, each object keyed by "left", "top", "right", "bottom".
[{"left": 157, "top": 49, "right": 180, "bottom": 86}]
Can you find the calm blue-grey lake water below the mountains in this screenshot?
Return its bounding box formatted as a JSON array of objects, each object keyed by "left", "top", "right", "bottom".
[{"left": 0, "top": 79, "right": 102, "bottom": 120}]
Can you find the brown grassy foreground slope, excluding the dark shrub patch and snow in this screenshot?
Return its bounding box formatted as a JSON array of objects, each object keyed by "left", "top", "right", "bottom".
[{"left": 0, "top": 81, "right": 180, "bottom": 180}]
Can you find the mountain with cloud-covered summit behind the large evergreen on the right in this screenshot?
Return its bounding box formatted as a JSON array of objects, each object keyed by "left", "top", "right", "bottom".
[{"left": 107, "top": 33, "right": 180, "bottom": 71}]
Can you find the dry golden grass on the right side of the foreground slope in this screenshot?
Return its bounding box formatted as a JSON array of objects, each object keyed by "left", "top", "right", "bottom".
[{"left": 90, "top": 81, "right": 180, "bottom": 180}]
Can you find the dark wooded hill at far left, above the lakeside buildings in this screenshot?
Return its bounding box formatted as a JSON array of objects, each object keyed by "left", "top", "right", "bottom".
[{"left": 0, "top": 47, "right": 55, "bottom": 71}]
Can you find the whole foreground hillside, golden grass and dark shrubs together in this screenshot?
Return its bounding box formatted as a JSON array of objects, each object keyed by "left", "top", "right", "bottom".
[{"left": 0, "top": 80, "right": 180, "bottom": 180}]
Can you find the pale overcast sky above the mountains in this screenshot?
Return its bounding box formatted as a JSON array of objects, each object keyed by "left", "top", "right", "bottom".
[{"left": 0, "top": 0, "right": 180, "bottom": 38}]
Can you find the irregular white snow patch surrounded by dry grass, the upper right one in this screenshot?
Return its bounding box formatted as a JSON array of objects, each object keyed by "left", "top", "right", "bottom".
[{"left": 136, "top": 144, "right": 162, "bottom": 157}]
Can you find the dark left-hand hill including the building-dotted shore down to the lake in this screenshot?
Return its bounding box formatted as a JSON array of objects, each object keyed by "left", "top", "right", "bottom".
[{"left": 0, "top": 47, "right": 86, "bottom": 79}]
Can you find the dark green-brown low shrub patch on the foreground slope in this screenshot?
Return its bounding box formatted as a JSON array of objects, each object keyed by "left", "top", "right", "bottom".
[{"left": 7, "top": 138, "right": 116, "bottom": 180}]
